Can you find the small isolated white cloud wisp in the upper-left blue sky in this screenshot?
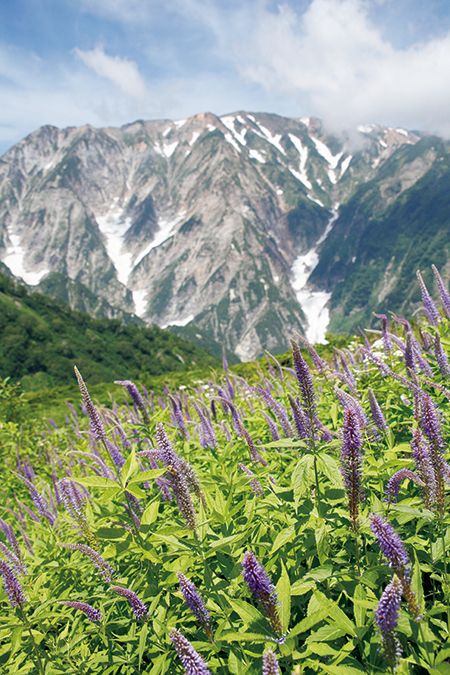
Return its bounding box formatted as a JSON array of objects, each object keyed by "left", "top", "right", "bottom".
[{"left": 74, "top": 47, "right": 146, "bottom": 97}]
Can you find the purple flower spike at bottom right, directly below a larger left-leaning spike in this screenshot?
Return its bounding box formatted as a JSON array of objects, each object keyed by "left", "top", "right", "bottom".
[{"left": 375, "top": 577, "right": 403, "bottom": 670}]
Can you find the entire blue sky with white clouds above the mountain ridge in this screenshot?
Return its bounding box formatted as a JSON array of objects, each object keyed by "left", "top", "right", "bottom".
[{"left": 0, "top": 0, "right": 450, "bottom": 150}]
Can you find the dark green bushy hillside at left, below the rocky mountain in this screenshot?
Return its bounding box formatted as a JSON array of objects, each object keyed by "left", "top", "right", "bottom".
[{"left": 0, "top": 274, "right": 217, "bottom": 389}]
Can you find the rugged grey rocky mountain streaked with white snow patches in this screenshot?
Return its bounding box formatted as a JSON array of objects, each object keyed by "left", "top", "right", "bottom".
[{"left": 0, "top": 112, "right": 450, "bottom": 360}]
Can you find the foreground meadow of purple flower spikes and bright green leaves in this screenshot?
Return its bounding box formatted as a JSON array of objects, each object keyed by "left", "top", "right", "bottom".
[{"left": 0, "top": 270, "right": 450, "bottom": 675}]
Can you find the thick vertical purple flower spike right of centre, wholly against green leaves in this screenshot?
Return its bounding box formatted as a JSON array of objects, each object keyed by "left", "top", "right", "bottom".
[{"left": 341, "top": 408, "right": 363, "bottom": 532}]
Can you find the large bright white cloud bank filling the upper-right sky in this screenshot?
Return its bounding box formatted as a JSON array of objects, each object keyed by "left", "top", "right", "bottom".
[{"left": 201, "top": 0, "right": 450, "bottom": 136}]
